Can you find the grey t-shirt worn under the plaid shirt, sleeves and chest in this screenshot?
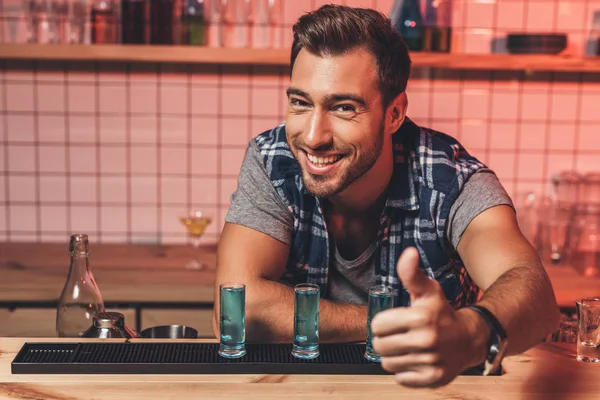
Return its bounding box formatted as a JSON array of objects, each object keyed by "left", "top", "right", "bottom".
[{"left": 225, "top": 141, "right": 513, "bottom": 304}]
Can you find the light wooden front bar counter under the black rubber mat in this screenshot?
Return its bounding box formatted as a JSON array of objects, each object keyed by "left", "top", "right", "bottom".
[{"left": 0, "top": 338, "right": 600, "bottom": 400}]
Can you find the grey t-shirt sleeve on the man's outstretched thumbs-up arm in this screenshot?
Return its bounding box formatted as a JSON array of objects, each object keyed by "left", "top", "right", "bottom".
[{"left": 447, "top": 169, "right": 514, "bottom": 249}]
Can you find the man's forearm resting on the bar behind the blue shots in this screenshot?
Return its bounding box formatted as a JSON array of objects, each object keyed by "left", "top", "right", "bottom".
[{"left": 246, "top": 279, "right": 367, "bottom": 343}]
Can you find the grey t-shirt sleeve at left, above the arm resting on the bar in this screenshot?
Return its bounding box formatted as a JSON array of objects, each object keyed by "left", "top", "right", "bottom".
[{"left": 225, "top": 141, "right": 294, "bottom": 244}]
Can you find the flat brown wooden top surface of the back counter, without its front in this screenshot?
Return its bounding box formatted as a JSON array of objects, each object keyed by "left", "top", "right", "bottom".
[{"left": 0, "top": 242, "right": 600, "bottom": 307}]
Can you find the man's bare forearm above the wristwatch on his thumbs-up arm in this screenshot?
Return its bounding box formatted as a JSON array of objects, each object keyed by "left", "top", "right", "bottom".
[{"left": 459, "top": 267, "right": 559, "bottom": 361}]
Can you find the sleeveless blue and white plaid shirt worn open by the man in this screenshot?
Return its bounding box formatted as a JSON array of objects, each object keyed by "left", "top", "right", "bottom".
[{"left": 254, "top": 118, "right": 485, "bottom": 308}]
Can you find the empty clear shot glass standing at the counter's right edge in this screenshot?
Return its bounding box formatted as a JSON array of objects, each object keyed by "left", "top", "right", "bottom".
[{"left": 576, "top": 297, "right": 600, "bottom": 363}]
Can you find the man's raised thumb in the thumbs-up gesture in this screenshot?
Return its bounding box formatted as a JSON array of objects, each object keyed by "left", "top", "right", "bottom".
[{"left": 396, "top": 247, "right": 437, "bottom": 301}]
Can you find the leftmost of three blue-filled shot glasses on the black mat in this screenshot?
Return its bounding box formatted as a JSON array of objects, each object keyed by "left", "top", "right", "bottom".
[{"left": 219, "top": 282, "right": 246, "bottom": 358}]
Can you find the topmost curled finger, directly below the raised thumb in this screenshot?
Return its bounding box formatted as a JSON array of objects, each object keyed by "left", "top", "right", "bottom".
[{"left": 371, "top": 308, "right": 430, "bottom": 336}]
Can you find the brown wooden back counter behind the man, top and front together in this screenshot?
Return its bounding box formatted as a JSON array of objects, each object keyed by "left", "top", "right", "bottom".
[{"left": 0, "top": 242, "right": 600, "bottom": 338}]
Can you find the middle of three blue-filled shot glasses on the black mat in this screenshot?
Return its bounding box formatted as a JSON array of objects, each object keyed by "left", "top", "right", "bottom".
[{"left": 292, "top": 283, "right": 320, "bottom": 359}]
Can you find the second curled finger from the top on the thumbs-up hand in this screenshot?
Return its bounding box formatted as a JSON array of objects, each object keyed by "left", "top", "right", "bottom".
[{"left": 373, "top": 329, "right": 439, "bottom": 357}]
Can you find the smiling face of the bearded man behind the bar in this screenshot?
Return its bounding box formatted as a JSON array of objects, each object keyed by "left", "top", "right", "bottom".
[{"left": 286, "top": 49, "right": 387, "bottom": 197}]
